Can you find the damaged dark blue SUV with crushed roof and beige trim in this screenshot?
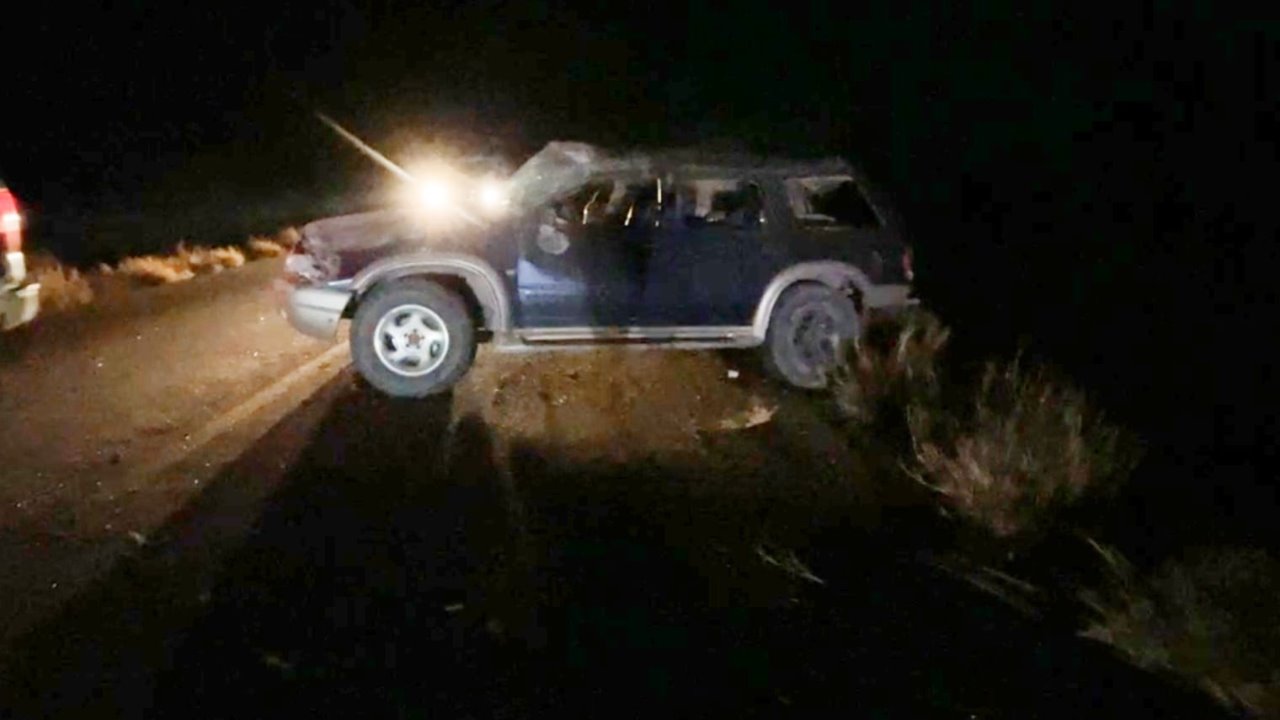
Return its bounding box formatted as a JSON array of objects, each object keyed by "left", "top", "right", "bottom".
[{"left": 283, "top": 142, "right": 913, "bottom": 397}]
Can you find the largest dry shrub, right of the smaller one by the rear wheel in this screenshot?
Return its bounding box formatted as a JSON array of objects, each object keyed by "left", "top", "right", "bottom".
[{"left": 908, "top": 360, "right": 1137, "bottom": 538}]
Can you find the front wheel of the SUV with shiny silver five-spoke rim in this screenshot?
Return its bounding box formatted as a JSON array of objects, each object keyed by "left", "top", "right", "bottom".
[{"left": 351, "top": 278, "right": 476, "bottom": 397}]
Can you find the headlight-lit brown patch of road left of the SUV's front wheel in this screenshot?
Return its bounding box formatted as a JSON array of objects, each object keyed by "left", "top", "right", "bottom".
[{"left": 0, "top": 260, "right": 340, "bottom": 645}]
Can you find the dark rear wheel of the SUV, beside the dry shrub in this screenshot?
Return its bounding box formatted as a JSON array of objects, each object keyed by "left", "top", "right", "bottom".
[{"left": 763, "top": 283, "right": 863, "bottom": 389}]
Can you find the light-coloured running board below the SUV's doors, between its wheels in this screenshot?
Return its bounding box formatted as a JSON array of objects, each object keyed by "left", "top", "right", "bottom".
[{"left": 499, "top": 325, "right": 760, "bottom": 350}]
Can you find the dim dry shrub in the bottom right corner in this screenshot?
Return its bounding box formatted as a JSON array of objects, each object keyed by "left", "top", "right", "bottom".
[{"left": 1083, "top": 544, "right": 1280, "bottom": 717}]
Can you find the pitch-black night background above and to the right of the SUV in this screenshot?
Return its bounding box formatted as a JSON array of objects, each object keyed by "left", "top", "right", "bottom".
[{"left": 0, "top": 0, "right": 1277, "bottom": 543}]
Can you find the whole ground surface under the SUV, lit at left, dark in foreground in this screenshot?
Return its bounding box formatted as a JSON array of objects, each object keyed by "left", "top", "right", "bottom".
[{"left": 0, "top": 263, "right": 1233, "bottom": 717}]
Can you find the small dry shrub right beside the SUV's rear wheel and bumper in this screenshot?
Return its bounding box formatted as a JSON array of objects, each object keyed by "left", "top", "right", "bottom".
[{"left": 833, "top": 309, "right": 951, "bottom": 427}]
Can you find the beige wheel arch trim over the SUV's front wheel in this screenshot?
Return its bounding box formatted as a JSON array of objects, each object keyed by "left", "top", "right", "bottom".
[{"left": 351, "top": 252, "right": 512, "bottom": 332}]
